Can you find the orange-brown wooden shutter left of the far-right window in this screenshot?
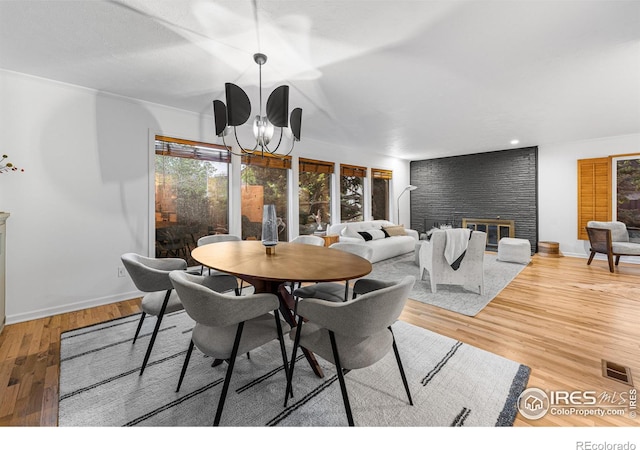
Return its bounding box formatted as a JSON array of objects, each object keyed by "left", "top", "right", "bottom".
[{"left": 578, "top": 157, "right": 611, "bottom": 240}]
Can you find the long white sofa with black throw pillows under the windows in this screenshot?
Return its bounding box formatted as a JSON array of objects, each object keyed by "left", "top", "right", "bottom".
[{"left": 327, "top": 220, "right": 419, "bottom": 263}]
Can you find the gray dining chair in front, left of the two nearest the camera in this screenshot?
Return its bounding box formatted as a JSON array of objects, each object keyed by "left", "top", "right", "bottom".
[{"left": 169, "top": 271, "right": 290, "bottom": 426}]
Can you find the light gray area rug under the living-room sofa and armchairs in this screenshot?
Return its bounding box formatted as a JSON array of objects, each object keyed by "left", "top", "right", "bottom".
[{"left": 366, "top": 252, "right": 526, "bottom": 316}]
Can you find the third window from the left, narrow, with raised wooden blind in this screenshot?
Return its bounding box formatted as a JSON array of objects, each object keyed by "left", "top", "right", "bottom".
[{"left": 298, "top": 158, "right": 335, "bottom": 235}]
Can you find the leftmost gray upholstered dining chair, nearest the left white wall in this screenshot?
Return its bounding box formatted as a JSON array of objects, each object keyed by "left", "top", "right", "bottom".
[{"left": 120, "top": 253, "right": 238, "bottom": 375}]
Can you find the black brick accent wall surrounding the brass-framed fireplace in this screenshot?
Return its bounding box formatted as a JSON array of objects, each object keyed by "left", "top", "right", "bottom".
[{"left": 410, "top": 147, "right": 538, "bottom": 251}]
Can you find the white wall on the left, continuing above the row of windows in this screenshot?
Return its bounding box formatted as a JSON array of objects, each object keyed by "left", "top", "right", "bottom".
[{"left": 0, "top": 71, "right": 409, "bottom": 323}]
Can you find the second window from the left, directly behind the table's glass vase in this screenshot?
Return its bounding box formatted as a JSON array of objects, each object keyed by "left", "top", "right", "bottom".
[{"left": 241, "top": 153, "right": 291, "bottom": 241}]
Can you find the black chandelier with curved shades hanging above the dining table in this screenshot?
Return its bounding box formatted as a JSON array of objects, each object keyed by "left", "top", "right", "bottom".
[{"left": 213, "top": 53, "right": 302, "bottom": 156}]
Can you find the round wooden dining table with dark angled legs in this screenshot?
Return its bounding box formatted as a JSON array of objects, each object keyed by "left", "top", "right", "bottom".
[{"left": 191, "top": 241, "right": 372, "bottom": 377}]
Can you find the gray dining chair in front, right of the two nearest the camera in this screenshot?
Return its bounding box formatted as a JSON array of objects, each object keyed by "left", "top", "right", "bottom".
[{"left": 284, "top": 276, "right": 415, "bottom": 426}]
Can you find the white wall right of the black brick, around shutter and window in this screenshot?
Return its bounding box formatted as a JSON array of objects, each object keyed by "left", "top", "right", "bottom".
[{"left": 538, "top": 134, "right": 640, "bottom": 262}]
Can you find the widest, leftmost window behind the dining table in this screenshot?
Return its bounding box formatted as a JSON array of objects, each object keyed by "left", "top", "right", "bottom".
[{"left": 155, "top": 136, "right": 230, "bottom": 259}]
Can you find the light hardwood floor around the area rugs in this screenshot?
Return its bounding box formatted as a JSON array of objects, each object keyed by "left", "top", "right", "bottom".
[{"left": 0, "top": 255, "right": 640, "bottom": 426}]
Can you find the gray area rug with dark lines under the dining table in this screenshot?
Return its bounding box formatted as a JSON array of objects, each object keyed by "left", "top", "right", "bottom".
[{"left": 59, "top": 311, "right": 530, "bottom": 427}]
